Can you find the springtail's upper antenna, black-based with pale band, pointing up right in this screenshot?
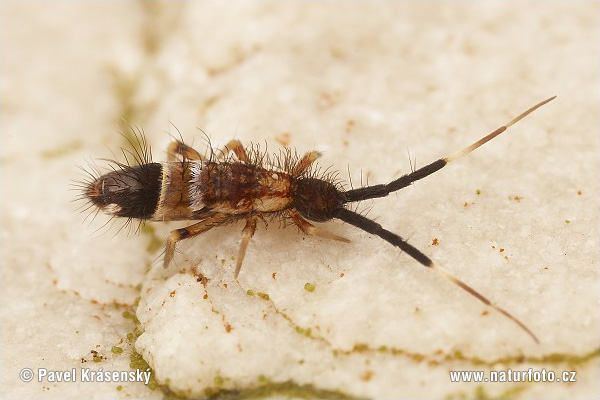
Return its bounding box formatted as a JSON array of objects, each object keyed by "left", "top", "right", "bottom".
[{"left": 344, "top": 96, "right": 556, "bottom": 203}]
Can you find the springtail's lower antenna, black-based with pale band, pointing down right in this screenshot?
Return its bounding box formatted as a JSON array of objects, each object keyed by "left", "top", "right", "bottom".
[{"left": 335, "top": 208, "right": 540, "bottom": 343}]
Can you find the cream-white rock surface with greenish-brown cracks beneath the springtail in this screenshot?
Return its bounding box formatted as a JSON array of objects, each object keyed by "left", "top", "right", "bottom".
[{"left": 0, "top": 2, "right": 600, "bottom": 398}]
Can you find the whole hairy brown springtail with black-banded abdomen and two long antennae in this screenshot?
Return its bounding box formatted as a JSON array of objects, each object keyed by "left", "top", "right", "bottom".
[{"left": 82, "top": 97, "right": 554, "bottom": 342}]
